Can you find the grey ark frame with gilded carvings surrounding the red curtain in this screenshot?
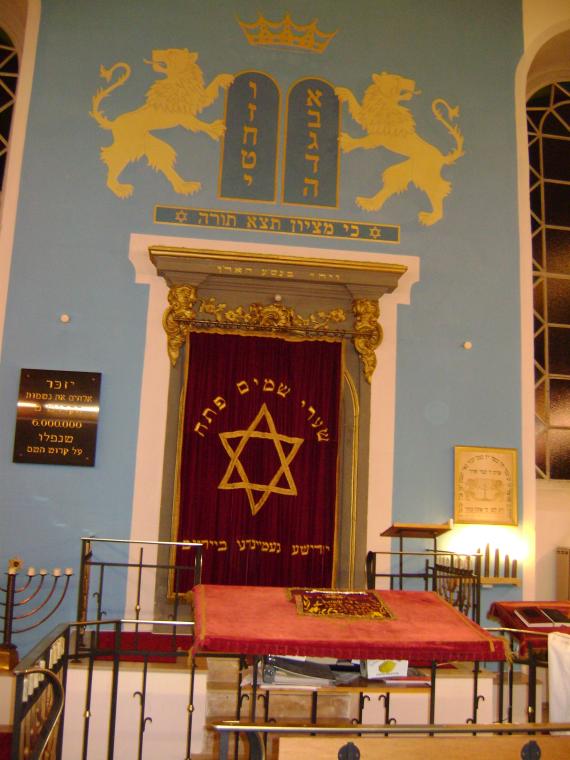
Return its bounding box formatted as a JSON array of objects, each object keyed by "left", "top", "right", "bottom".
[{"left": 149, "top": 246, "right": 407, "bottom": 605}]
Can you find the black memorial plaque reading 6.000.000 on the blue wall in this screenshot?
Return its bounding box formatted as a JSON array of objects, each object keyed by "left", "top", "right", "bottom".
[{"left": 13, "top": 369, "right": 101, "bottom": 467}]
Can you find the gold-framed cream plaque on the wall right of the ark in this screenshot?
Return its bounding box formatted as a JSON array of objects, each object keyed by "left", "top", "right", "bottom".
[{"left": 454, "top": 446, "right": 518, "bottom": 525}]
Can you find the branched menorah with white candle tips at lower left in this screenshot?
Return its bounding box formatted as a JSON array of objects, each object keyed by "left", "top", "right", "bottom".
[{"left": 0, "top": 559, "right": 73, "bottom": 670}]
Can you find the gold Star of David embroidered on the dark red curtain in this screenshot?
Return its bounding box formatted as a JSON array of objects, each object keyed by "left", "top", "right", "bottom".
[{"left": 218, "top": 404, "right": 303, "bottom": 515}]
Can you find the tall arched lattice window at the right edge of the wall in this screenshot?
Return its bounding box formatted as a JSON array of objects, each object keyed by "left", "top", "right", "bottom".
[{"left": 527, "top": 81, "right": 570, "bottom": 480}]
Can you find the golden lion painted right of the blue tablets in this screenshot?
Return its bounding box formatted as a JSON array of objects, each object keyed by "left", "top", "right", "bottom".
[{"left": 335, "top": 72, "right": 464, "bottom": 225}]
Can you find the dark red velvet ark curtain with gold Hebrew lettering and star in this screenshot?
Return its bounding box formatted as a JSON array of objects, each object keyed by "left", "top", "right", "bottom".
[{"left": 175, "top": 332, "right": 342, "bottom": 591}]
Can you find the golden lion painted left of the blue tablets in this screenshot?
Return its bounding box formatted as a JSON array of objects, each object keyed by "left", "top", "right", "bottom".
[{"left": 90, "top": 49, "right": 233, "bottom": 198}]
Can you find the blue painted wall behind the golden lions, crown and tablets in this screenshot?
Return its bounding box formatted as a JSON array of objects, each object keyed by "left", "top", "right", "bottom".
[{"left": 0, "top": 0, "right": 522, "bottom": 648}]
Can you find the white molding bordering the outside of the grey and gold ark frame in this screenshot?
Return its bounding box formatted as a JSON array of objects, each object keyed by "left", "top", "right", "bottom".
[{"left": 125, "top": 233, "right": 414, "bottom": 612}]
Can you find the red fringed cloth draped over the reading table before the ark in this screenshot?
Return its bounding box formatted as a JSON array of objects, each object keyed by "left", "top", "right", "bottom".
[{"left": 191, "top": 584, "right": 506, "bottom": 665}]
